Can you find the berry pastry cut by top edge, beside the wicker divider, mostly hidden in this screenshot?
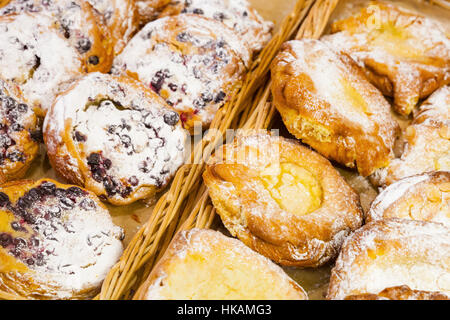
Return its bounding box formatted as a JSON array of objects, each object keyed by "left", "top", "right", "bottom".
[{"left": 156, "top": 0, "right": 273, "bottom": 52}]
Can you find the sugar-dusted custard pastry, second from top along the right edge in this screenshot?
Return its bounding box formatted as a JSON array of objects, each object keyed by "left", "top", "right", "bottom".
[{"left": 371, "top": 86, "right": 450, "bottom": 186}]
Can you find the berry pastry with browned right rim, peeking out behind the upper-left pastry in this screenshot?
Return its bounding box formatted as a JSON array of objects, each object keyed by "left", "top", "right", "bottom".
[{"left": 0, "top": 0, "right": 113, "bottom": 72}]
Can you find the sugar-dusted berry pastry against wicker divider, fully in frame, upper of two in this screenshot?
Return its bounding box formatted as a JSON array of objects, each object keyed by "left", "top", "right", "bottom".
[{"left": 113, "top": 15, "right": 250, "bottom": 132}]
